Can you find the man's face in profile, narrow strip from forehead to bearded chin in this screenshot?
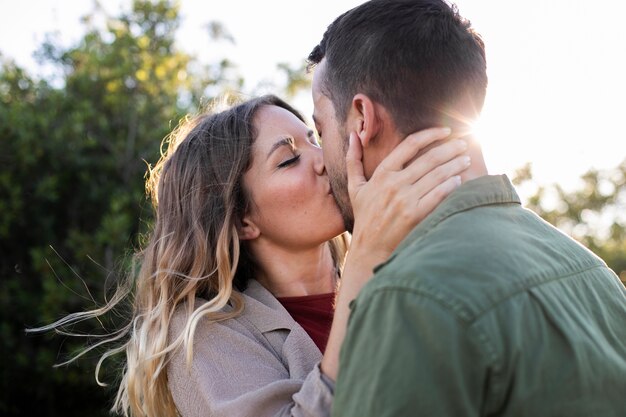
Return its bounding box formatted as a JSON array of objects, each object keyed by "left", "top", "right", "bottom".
[{"left": 312, "top": 59, "right": 354, "bottom": 232}]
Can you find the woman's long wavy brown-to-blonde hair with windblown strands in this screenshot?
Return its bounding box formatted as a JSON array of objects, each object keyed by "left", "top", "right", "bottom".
[{"left": 31, "top": 95, "right": 347, "bottom": 417}]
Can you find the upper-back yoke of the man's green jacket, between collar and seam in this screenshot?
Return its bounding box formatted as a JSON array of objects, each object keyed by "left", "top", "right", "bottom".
[{"left": 362, "top": 202, "right": 606, "bottom": 319}]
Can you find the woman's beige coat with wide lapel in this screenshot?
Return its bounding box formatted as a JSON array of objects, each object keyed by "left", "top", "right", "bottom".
[{"left": 167, "top": 280, "right": 334, "bottom": 417}]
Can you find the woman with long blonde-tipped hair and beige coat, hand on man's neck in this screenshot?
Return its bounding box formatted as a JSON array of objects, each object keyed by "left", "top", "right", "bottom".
[{"left": 33, "top": 96, "right": 466, "bottom": 417}]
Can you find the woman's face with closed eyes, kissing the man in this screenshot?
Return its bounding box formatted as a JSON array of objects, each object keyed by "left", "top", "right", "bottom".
[{"left": 242, "top": 105, "right": 344, "bottom": 249}]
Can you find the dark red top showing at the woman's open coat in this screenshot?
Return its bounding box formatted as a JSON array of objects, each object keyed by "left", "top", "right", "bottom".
[{"left": 277, "top": 292, "right": 335, "bottom": 353}]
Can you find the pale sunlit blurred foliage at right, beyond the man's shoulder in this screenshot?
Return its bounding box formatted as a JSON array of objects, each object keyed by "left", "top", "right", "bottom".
[{"left": 513, "top": 159, "right": 626, "bottom": 282}]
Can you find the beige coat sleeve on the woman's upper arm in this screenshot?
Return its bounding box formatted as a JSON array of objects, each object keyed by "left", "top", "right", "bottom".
[{"left": 167, "top": 312, "right": 333, "bottom": 417}]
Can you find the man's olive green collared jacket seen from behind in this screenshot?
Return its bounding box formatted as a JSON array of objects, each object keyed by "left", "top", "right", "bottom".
[{"left": 333, "top": 176, "right": 626, "bottom": 417}]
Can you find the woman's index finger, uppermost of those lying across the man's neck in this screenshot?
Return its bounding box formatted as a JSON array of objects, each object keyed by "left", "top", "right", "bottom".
[{"left": 379, "top": 127, "right": 451, "bottom": 171}]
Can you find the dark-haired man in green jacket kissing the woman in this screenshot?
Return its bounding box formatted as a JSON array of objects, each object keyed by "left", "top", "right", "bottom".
[{"left": 309, "top": 0, "right": 626, "bottom": 417}]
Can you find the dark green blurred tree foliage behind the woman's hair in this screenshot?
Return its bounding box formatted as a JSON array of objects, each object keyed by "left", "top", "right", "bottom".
[{"left": 0, "top": 0, "right": 242, "bottom": 416}]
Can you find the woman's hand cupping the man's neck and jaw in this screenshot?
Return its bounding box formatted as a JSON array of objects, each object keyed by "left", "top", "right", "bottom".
[{"left": 346, "top": 128, "right": 470, "bottom": 267}]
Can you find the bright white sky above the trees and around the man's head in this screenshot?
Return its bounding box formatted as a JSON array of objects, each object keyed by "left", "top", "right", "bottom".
[{"left": 0, "top": 0, "right": 626, "bottom": 197}]
